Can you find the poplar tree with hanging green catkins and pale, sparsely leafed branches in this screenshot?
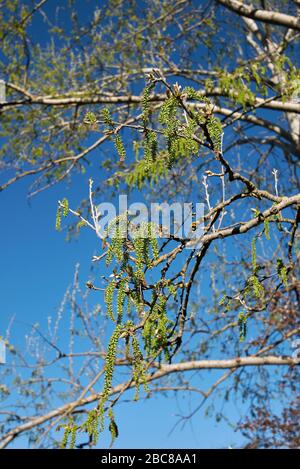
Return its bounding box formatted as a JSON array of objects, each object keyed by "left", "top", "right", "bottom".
[{"left": 0, "top": 0, "right": 300, "bottom": 448}]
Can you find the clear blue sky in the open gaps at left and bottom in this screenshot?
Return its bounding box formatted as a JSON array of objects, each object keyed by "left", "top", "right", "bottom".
[{"left": 0, "top": 2, "right": 292, "bottom": 448}]
